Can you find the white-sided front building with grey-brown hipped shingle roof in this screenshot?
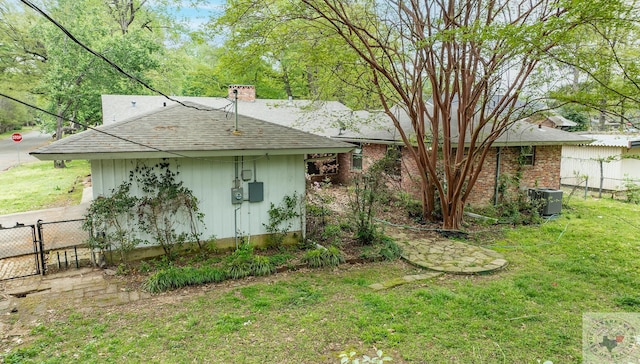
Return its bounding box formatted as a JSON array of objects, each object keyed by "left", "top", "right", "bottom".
[{"left": 31, "top": 101, "right": 352, "bottom": 255}]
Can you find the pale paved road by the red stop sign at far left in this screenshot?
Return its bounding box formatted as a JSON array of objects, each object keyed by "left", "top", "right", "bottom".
[{"left": 0, "top": 131, "right": 52, "bottom": 172}]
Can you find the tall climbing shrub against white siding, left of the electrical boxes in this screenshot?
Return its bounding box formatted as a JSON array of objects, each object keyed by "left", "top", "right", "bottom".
[{"left": 129, "top": 162, "right": 204, "bottom": 257}]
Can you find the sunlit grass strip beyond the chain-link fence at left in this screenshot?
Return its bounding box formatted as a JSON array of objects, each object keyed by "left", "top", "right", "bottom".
[{"left": 0, "top": 161, "right": 90, "bottom": 215}]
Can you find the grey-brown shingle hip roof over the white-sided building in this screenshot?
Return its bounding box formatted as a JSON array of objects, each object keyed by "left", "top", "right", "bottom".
[{"left": 31, "top": 102, "right": 352, "bottom": 159}]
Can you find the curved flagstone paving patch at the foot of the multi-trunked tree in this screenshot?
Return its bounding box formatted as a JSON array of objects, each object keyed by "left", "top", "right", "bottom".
[{"left": 388, "top": 231, "right": 508, "bottom": 274}]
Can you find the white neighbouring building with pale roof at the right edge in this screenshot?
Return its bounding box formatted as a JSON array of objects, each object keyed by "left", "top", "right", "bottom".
[{"left": 561, "top": 134, "right": 640, "bottom": 191}]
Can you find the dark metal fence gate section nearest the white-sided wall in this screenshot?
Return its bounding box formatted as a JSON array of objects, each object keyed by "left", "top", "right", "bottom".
[{"left": 37, "top": 219, "right": 90, "bottom": 273}]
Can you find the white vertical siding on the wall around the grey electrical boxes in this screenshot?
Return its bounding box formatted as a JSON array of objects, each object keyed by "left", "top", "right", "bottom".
[{"left": 91, "top": 155, "right": 305, "bottom": 239}]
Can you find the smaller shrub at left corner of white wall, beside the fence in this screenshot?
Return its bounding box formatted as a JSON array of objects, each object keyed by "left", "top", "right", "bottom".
[{"left": 82, "top": 182, "right": 141, "bottom": 263}]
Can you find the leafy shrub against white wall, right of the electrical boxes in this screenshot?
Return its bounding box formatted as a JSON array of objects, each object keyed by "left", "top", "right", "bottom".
[{"left": 263, "top": 192, "right": 302, "bottom": 247}]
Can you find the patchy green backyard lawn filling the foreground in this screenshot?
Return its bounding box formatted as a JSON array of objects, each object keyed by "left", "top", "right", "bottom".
[{"left": 0, "top": 199, "right": 640, "bottom": 363}]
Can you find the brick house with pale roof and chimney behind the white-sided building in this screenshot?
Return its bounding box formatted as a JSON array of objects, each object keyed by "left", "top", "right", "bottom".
[{"left": 95, "top": 85, "right": 588, "bottom": 208}]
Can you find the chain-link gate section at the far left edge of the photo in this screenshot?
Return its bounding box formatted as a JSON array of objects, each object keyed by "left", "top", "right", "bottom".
[{"left": 0, "top": 224, "right": 44, "bottom": 281}]
